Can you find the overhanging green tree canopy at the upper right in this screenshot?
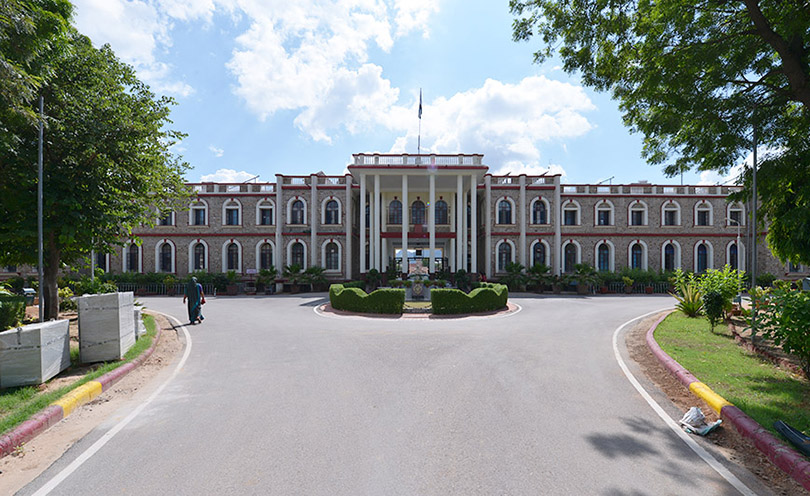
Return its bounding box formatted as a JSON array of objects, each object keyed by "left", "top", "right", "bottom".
[{"left": 510, "top": 0, "right": 810, "bottom": 263}]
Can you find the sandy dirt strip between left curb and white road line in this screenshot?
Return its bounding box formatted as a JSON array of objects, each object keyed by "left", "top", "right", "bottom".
[{"left": 0, "top": 311, "right": 183, "bottom": 494}]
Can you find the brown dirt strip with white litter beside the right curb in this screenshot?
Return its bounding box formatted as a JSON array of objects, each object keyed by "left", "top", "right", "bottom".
[{"left": 626, "top": 314, "right": 810, "bottom": 496}]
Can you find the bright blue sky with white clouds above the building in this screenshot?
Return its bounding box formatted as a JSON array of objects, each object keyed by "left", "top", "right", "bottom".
[{"left": 73, "top": 0, "right": 740, "bottom": 184}]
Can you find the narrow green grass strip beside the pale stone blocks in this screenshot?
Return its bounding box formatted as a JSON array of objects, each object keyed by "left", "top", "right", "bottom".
[{"left": 0, "top": 315, "right": 157, "bottom": 434}]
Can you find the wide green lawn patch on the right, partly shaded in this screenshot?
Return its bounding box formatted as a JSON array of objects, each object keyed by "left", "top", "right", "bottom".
[{"left": 655, "top": 312, "right": 810, "bottom": 433}]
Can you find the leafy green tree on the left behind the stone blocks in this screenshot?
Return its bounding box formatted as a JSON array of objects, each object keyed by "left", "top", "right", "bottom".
[{"left": 0, "top": 32, "right": 187, "bottom": 318}]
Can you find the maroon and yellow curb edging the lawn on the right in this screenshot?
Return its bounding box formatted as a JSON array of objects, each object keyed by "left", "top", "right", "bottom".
[{"left": 647, "top": 314, "right": 810, "bottom": 491}]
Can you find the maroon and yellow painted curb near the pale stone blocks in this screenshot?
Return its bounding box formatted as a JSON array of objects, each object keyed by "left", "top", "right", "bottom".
[{"left": 0, "top": 312, "right": 161, "bottom": 458}]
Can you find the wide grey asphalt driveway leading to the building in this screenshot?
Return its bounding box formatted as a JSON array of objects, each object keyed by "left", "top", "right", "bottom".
[{"left": 20, "top": 294, "right": 763, "bottom": 495}]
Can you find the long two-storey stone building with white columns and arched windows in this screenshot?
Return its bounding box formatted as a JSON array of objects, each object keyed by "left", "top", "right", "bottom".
[{"left": 36, "top": 153, "right": 796, "bottom": 280}]
